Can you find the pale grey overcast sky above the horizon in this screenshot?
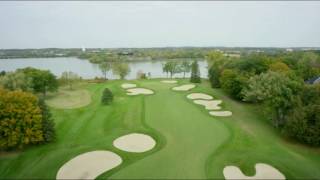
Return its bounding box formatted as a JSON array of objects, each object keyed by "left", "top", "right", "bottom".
[{"left": 0, "top": 1, "right": 320, "bottom": 48}]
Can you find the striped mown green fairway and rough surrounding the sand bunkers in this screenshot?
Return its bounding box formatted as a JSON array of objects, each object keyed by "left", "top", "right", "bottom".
[{"left": 0, "top": 79, "right": 320, "bottom": 179}]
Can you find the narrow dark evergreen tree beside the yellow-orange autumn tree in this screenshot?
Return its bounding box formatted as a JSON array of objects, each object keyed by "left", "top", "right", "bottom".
[{"left": 38, "top": 98, "right": 56, "bottom": 142}]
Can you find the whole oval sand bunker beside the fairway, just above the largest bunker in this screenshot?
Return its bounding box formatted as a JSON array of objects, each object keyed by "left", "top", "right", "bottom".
[{"left": 113, "top": 133, "right": 156, "bottom": 152}]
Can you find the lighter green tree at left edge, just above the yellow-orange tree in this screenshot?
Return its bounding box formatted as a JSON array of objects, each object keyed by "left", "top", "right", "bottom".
[{"left": 0, "top": 72, "right": 32, "bottom": 91}]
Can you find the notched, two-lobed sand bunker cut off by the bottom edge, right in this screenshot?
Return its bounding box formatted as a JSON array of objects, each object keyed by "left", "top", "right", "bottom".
[{"left": 223, "top": 163, "right": 285, "bottom": 179}]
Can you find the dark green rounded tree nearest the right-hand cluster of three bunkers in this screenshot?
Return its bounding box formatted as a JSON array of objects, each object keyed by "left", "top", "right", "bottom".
[{"left": 220, "top": 69, "right": 248, "bottom": 100}]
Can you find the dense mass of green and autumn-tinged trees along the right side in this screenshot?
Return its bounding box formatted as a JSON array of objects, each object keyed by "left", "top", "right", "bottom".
[{"left": 207, "top": 52, "right": 320, "bottom": 146}]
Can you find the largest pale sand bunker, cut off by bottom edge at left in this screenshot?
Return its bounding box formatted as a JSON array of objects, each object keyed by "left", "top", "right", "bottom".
[{"left": 56, "top": 151, "right": 122, "bottom": 179}]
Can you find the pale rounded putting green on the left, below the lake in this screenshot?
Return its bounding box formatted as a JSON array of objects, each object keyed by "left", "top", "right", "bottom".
[{"left": 46, "top": 89, "right": 91, "bottom": 109}]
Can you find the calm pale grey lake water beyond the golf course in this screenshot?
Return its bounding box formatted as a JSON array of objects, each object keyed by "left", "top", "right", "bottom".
[{"left": 0, "top": 57, "right": 208, "bottom": 79}]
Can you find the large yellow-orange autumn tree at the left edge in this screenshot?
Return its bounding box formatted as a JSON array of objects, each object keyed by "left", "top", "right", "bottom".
[{"left": 0, "top": 89, "right": 44, "bottom": 149}]
